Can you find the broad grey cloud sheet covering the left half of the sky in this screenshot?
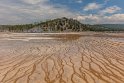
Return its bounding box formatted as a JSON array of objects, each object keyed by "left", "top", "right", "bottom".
[{"left": 0, "top": 0, "right": 75, "bottom": 24}]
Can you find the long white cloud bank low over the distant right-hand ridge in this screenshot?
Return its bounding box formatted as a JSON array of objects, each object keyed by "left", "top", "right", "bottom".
[{"left": 75, "top": 14, "right": 124, "bottom": 24}]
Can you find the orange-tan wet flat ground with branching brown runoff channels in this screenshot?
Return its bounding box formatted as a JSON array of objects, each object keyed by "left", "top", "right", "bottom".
[{"left": 0, "top": 32, "right": 124, "bottom": 83}]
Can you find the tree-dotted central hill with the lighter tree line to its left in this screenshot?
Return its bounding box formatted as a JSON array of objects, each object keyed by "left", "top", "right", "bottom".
[{"left": 0, "top": 17, "right": 89, "bottom": 32}]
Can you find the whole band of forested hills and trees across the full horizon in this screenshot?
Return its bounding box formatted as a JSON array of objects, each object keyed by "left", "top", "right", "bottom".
[{"left": 0, "top": 17, "right": 124, "bottom": 33}]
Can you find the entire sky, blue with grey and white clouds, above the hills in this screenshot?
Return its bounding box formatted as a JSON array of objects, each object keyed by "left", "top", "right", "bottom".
[{"left": 0, "top": 0, "right": 124, "bottom": 24}]
